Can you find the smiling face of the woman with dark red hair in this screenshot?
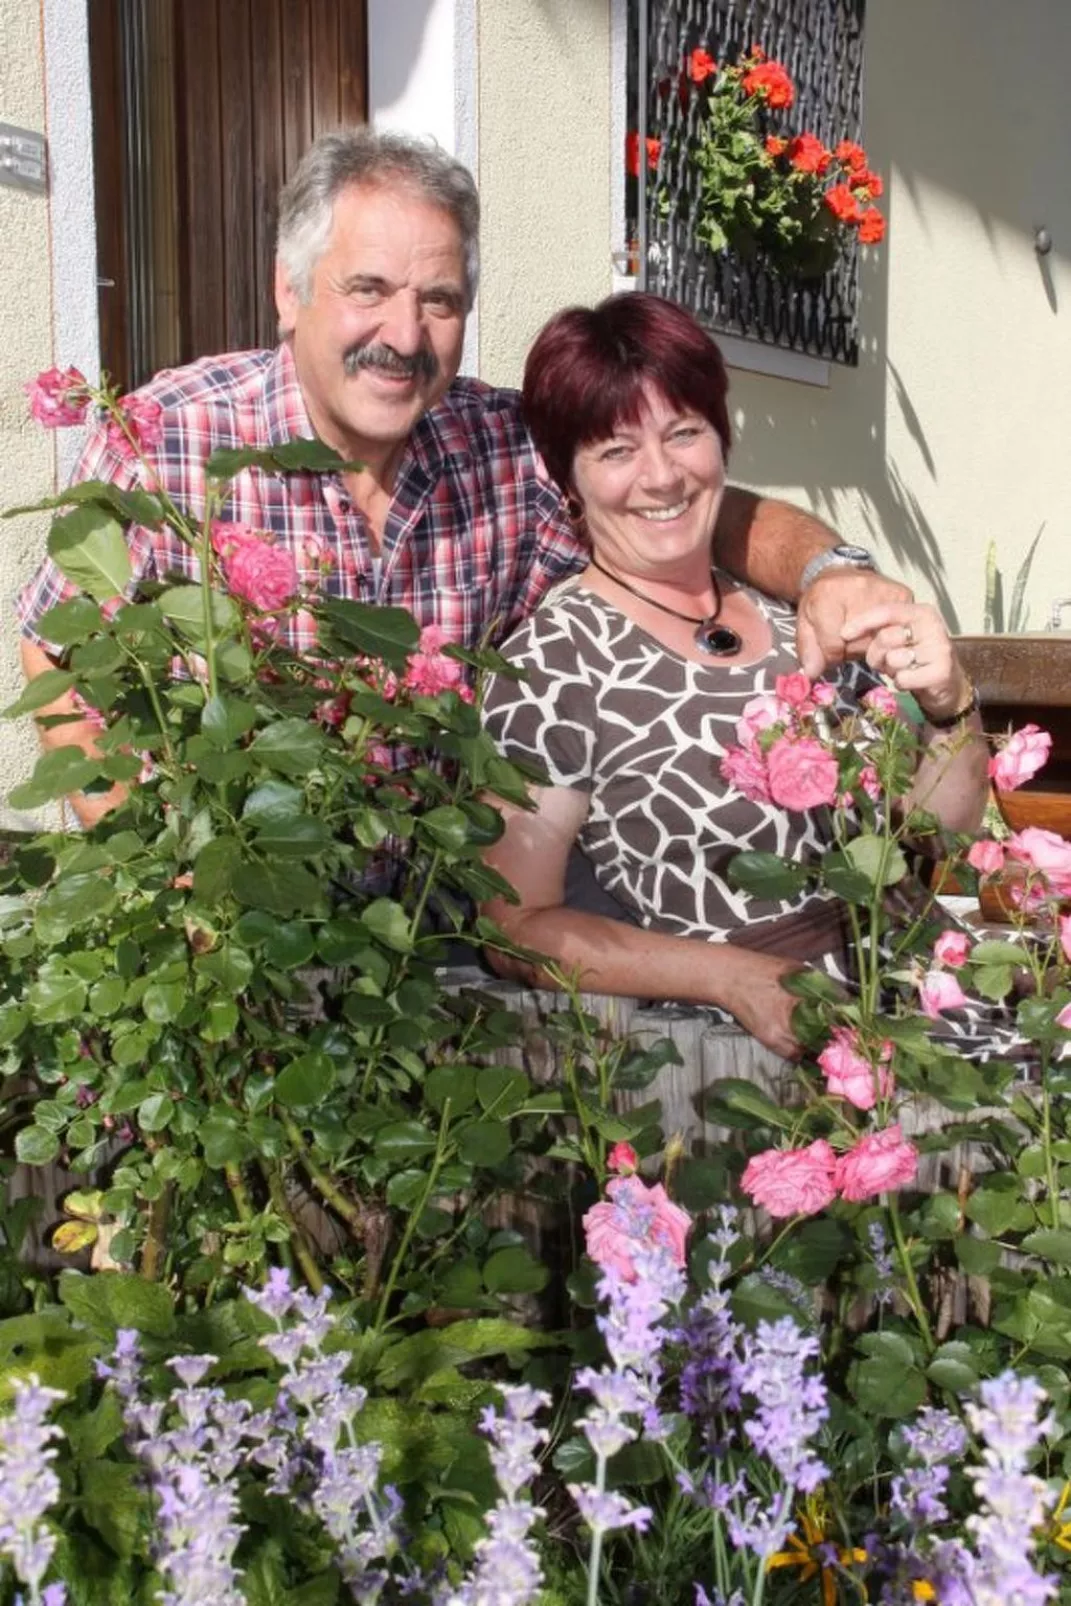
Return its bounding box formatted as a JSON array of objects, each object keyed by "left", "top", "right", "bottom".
[{"left": 573, "top": 384, "right": 726, "bottom": 578}]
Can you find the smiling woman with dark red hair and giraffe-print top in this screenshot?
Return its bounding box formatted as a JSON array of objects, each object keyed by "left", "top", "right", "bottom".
[{"left": 485, "top": 294, "right": 986, "bottom": 1057}]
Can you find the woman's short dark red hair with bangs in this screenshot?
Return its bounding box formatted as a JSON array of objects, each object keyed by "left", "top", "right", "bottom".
[{"left": 522, "top": 292, "right": 731, "bottom": 490}]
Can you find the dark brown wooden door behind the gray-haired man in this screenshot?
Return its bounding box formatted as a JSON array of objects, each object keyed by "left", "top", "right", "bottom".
[{"left": 88, "top": 0, "right": 368, "bottom": 389}]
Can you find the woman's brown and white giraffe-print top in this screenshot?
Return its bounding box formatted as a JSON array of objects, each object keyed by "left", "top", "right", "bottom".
[{"left": 483, "top": 577, "right": 877, "bottom": 968}]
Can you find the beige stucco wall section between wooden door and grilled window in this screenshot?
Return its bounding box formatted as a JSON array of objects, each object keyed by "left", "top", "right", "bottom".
[{"left": 478, "top": 0, "right": 612, "bottom": 384}]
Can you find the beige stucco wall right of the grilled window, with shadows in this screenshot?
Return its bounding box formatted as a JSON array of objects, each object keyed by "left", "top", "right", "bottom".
[{"left": 734, "top": 0, "right": 1071, "bottom": 630}]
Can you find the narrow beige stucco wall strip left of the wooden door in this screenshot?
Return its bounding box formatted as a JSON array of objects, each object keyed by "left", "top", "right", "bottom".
[{"left": 0, "top": 0, "right": 56, "bottom": 817}]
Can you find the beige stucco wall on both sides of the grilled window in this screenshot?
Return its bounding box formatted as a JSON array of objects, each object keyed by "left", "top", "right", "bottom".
[{"left": 478, "top": 0, "right": 1071, "bottom": 628}]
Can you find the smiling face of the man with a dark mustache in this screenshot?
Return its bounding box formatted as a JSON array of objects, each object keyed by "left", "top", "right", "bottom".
[{"left": 276, "top": 183, "right": 467, "bottom": 466}]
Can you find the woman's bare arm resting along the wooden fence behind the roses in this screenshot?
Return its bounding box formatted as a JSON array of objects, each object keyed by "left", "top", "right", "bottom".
[{"left": 483, "top": 787, "right": 800, "bottom": 1058}]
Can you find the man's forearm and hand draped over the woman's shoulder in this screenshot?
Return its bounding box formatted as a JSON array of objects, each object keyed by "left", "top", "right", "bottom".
[{"left": 715, "top": 485, "right": 914, "bottom": 679}]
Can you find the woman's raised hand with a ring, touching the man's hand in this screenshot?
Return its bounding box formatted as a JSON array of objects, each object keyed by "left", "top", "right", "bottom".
[{"left": 845, "top": 602, "right": 971, "bottom": 719}]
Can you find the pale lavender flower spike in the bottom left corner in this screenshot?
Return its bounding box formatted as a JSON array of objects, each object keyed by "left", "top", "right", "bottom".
[{"left": 0, "top": 1373, "right": 66, "bottom": 1606}]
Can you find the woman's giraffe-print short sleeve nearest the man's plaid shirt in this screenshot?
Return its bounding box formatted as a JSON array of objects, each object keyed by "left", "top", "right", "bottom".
[{"left": 482, "top": 609, "right": 596, "bottom": 792}]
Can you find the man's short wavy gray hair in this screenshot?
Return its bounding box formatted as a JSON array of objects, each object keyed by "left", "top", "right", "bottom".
[{"left": 276, "top": 127, "right": 480, "bottom": 307}]
